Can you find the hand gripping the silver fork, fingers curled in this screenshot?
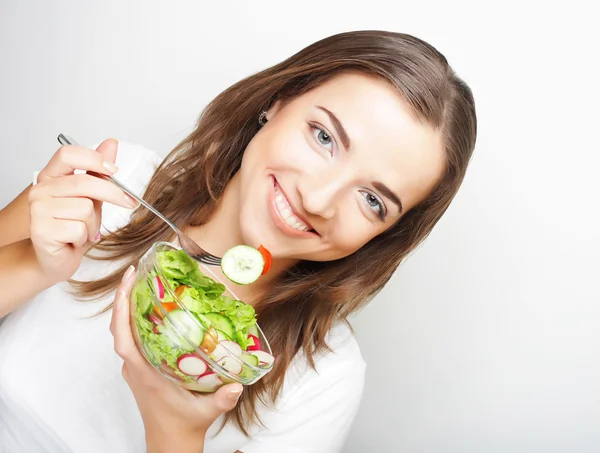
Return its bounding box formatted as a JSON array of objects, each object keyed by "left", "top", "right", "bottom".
[{"left": 29, "top": 139, "right": 137, "bottom": 284}]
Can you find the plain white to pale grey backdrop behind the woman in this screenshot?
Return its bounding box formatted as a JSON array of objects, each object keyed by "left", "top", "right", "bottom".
[{"left": 0, "top": 0, "right": 600, "bottom": 453}]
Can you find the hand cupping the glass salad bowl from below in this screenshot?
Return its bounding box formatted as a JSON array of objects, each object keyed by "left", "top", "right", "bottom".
[{"left": 110, "top": 266, "right": 242, "bottom": 452}]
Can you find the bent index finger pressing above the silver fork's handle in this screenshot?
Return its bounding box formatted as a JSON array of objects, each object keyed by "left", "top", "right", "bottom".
[{"left": 38, "top": 139, "right": 117, "bottom": 182}]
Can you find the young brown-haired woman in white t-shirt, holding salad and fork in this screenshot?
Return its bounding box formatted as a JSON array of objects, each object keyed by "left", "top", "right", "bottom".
[{"left": 0, "top": 31, "right": 476, "bottom": 453}]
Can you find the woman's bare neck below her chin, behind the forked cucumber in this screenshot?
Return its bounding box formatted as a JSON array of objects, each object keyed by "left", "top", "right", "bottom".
[{"left": 184, "top": 175, "right": 294, "bottom": 305}]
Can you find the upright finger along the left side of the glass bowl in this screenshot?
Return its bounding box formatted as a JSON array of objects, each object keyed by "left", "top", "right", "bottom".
[{"left": 110, "top": 266, "right": 143, "bottom": 362}]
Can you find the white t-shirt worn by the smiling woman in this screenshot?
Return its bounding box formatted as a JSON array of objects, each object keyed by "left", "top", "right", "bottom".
[{"left": 0, "top": 143, "right": 366, "bottom": 453}]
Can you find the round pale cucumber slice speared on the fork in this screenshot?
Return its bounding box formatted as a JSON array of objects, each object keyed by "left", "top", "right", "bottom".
[{"left": 221, "top": 245, "right": 265, "bottom": 285}]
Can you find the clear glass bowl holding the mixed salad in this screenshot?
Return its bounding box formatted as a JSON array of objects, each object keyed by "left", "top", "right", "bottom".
[{"left": 130, "top": 242, "right": 273, "bottom": 392}]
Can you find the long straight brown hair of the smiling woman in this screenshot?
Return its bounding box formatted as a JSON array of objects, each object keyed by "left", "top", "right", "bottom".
[{"left": 72, "top": 31, "right": 477, "bottom": 432}]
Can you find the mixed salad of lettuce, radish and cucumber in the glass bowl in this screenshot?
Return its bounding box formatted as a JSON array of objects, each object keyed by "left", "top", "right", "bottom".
[{"left": 131, "top": 245, "right": 274, "bottom": 392}]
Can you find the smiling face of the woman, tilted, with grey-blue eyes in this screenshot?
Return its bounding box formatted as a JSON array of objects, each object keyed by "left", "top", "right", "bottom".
[{"left": 238, "top": 74, "right": 444, "bottom": 261}]
